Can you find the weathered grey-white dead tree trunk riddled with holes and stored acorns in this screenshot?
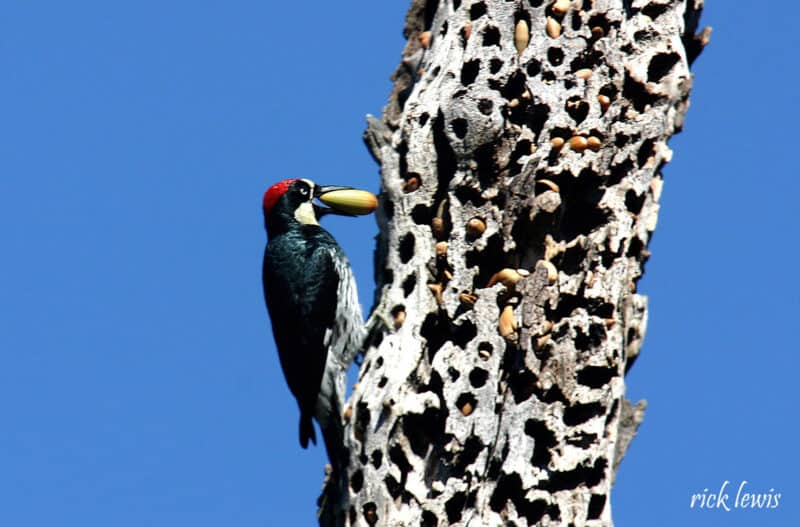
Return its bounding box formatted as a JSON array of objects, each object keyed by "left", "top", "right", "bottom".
[{"left": 321, "top": 0, "right": 708, "bottom": 526}]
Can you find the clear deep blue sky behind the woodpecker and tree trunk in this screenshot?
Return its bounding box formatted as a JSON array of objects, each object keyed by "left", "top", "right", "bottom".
[{"left": 0, "top": 0, "right": 800, "bottom": 527}]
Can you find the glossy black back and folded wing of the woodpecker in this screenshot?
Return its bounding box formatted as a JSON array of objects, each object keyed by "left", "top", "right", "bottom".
[{"left": 263, "top": 226, "right": 339, "bottom": 447}]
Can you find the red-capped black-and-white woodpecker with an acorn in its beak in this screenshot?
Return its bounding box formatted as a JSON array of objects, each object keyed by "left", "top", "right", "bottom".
[{"left": 262, "top": 179, "right": 377, "bottom": 469}]
